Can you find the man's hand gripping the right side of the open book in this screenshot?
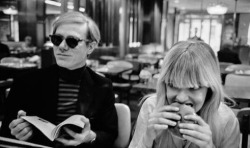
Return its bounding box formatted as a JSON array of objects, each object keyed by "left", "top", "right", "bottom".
[{"left": 56, "top": 117, "right": 96, "bottom": 146}]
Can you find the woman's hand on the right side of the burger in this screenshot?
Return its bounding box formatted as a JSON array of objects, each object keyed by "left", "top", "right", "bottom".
[{"left": 179, "top": 115, "right": 214, "bottom": 148}]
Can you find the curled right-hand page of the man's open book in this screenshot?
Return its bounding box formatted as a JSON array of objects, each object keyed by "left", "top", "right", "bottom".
[{"left": 52, "top": 115, "right": 85, "bottom": 139}]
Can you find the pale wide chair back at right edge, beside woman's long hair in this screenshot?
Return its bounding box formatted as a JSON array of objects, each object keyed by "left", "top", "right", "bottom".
[{"left": 225, "top": 74, "right": 250, "bottom": 87}]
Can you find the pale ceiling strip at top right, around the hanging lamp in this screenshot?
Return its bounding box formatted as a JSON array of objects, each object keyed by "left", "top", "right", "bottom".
[{"left": 168, "top": 0, "right": 250, "bottom": 13}]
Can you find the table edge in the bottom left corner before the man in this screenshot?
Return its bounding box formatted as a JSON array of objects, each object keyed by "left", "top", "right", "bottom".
[{"left": 0, "top": 137, "right": 51, "bottom": 148}]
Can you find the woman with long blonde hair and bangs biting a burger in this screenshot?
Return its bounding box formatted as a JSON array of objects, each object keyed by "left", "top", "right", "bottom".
[{"left": 129, "top": 40, "right": 240, "bottom": 148}]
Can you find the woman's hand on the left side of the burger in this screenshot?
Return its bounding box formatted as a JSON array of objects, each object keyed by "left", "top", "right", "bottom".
[{"left": 144, "top": 105, "right": 181, "bottom": 147}]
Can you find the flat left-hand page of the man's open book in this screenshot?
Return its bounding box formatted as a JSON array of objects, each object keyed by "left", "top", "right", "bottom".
[{"left": 21, "top": 116, "right": 56, "bottom": 141}]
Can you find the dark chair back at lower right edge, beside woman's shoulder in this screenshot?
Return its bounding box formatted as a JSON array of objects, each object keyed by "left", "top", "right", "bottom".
[{"left": 237, "top": 107, "right": 250, "bottom": 148}]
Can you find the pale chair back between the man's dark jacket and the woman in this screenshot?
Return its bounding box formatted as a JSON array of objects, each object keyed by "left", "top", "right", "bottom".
[{"left": 114, "top": 103, "right": 131, "bottom": 148}]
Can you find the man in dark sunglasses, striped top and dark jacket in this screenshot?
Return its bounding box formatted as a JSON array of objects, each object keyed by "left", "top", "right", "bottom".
[{"left": 1, "top": 12, "right": 118, "bottom": 148}]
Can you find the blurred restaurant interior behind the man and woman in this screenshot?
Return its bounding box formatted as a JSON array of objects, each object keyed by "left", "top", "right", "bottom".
[{"left": 0, "top": 0, "right": 250, "bottom": 145}]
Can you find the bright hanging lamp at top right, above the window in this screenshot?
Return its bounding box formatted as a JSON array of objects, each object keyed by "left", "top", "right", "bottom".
[{"left": 207, "top": 3, "right": 228, "bottom": 15}]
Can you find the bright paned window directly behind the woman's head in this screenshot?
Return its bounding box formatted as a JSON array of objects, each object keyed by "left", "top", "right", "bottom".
[{"left": 178, "top": 14, "right": 223, "bottom": 53}]
